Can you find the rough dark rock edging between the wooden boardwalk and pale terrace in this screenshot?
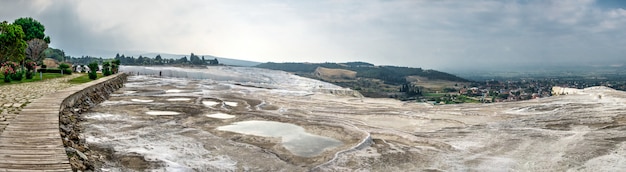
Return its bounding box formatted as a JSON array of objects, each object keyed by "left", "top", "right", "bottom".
[{"left": 59, "top": 73, "right": 128, "bottom": 171}]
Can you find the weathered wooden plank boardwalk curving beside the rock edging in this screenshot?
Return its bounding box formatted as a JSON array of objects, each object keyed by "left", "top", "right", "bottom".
[{"left": 0, "top": 96, "right": 71, "bottom": 171}]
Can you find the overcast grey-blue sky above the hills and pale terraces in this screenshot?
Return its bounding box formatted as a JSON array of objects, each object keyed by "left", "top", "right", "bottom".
[{"left": 0, "top": 0, "right": 626, "bottom": 69}]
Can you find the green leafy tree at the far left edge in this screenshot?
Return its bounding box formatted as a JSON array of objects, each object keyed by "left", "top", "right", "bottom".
[{"left": 0, "top": 21, "right": 27, "bottom": 62}]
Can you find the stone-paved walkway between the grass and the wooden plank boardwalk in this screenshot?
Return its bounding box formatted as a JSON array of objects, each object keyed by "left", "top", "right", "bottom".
[{"left": 0, "top": 74, "right": 81, "bottom": 133}]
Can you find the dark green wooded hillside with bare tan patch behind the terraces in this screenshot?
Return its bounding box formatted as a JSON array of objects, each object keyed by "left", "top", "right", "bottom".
[{"left": 256, "top": 62, "right": 469, "bottom": 99}]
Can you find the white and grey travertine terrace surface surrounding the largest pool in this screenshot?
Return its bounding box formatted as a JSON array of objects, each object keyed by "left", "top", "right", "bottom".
[{"left": 83, "top": 67, "right": 626, "bottom": 171}]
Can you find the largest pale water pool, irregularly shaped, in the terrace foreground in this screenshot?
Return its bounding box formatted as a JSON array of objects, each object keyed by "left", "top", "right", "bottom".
[{"left": 217, "top": 121, "right": 343, "bottom": 157}]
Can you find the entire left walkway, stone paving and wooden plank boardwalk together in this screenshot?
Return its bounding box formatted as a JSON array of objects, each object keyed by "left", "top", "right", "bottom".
[{"left": 0, "top": 75, "right": 80, "bottom": 171}]
